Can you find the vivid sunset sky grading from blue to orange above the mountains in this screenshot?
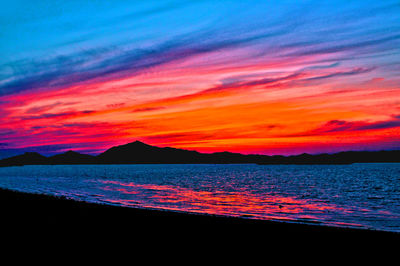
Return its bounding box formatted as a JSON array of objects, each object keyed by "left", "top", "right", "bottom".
[{"left": 0, "top": 0, "right": 400, "bottom": 157}]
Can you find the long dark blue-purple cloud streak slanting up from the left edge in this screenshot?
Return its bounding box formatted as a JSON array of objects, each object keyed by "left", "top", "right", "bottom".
[{"left": 0, "top": 21, "right": 296, "bottom": 96}]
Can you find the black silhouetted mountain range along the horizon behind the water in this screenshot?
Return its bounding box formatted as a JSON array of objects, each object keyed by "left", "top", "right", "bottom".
[{"left": 0, "top": 141, "right": 400, "bottom": 166}]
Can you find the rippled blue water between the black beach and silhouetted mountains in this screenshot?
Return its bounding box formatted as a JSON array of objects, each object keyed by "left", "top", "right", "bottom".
[{"left": 0, "top": 163, "right": 400, "bottom": 232}]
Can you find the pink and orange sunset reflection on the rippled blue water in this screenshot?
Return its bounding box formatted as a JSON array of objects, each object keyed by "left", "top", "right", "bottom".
[{"left": 100, "top": 180, "right": 358, "bottom": 226}]
